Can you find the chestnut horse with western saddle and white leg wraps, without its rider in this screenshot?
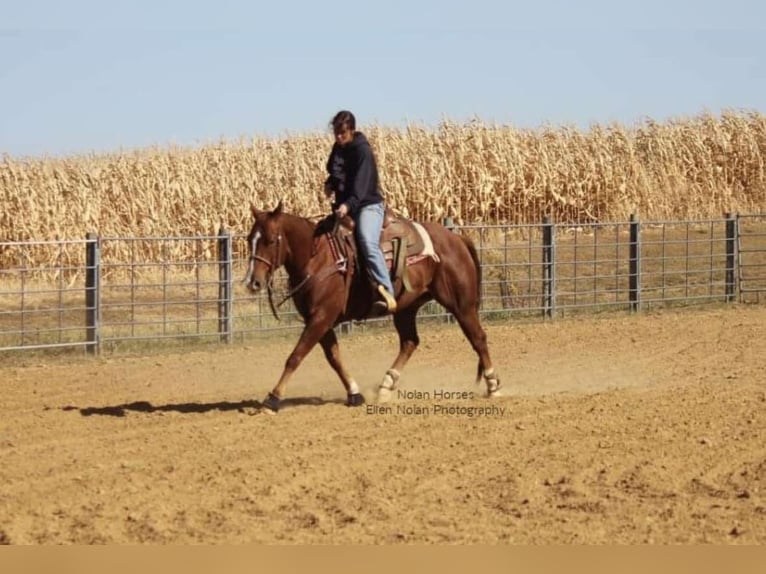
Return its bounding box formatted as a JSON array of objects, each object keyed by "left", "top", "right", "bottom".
[{"left": 244, "top": 200, "right": 500, "bottom": 414}]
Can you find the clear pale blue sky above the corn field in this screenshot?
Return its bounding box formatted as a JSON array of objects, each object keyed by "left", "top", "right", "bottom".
[{"left": 0, "top": 0, "right": 766, "bottom": 157}]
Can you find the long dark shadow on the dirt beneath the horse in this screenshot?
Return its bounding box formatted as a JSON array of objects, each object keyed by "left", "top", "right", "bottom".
[{"left": 61, "top": 397, "right": 345, "bottom": 417}]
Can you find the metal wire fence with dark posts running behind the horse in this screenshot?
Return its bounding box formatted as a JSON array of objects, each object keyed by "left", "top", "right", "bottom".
[{"left": 0, "top": 215, "right": 766, "bottom": 352}]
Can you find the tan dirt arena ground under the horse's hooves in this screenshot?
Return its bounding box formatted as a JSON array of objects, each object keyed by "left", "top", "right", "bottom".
[{"left": 0, "top": 306, "right": 766, "bottom": 544}]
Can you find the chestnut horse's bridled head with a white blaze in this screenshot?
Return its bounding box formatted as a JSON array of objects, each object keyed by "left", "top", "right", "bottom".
[{"left": 244, "top": 201, "right": 286, "bottom": 293}]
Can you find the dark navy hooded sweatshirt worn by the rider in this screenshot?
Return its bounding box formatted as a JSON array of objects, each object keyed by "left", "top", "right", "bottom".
[{"left": 327, "top": 132, "right": 383, "bottom": 217}]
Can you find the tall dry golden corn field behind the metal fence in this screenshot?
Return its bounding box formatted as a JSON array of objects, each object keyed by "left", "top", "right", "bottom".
[{"left": 0, "top": 111, "right": 766, "bottom": 266}]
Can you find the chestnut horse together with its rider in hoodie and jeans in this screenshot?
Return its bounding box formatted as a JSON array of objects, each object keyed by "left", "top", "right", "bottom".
[{"left": 244, "top": 110, "right": 500, "bottom": 414}]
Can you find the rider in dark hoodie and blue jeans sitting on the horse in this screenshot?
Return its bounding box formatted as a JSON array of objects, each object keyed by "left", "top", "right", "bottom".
[{"left": 325, "top": 110, "right": 396, "bottom": 313}]
